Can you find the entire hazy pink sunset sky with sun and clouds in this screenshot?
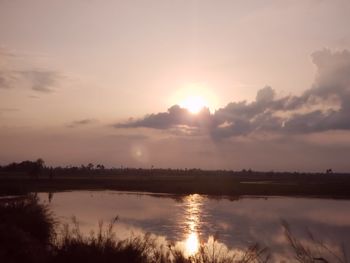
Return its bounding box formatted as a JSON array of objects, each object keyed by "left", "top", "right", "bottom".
[{"left": 0, "top": 0, "right": 350, "bottom": 172}]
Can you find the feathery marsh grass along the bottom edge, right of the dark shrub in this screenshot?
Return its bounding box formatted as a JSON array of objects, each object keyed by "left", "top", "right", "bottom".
[{"left": 52, "top": 217, "right": 269, "bottom": 263}]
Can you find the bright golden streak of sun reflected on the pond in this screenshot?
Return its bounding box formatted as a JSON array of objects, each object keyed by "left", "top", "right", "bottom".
[{"left": 184, "top": 194, "right": 203, "bottom": 256}]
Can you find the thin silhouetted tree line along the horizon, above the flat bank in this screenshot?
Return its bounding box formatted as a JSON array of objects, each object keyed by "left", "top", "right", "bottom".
[{"left": 0, "top": 158, "right": 348, "bottom": 179}]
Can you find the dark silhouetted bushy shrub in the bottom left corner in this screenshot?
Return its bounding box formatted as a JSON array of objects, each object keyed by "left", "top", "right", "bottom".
[{"left": 0, "top": 195, "right": 55, "bottom": 262}]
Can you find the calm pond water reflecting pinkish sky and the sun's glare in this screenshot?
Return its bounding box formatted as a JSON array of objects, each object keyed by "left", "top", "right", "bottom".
[{"left": 39, "top": 191, "right": 350, "bottom": 259}]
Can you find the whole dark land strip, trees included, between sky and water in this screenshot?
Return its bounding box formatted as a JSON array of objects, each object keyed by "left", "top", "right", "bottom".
[{"left": 0, "top": 159, "right": 350, "bottom": 198}]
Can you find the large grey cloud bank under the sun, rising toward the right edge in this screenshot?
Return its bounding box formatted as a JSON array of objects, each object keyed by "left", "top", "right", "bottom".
[{"left": 114, "top": 49, "right": 350, "bottom": 139}]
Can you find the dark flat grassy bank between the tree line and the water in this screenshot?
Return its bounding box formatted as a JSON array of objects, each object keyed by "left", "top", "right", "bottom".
[{"left": 0, "top": 174, "right": 350, "bottom": 198}]
